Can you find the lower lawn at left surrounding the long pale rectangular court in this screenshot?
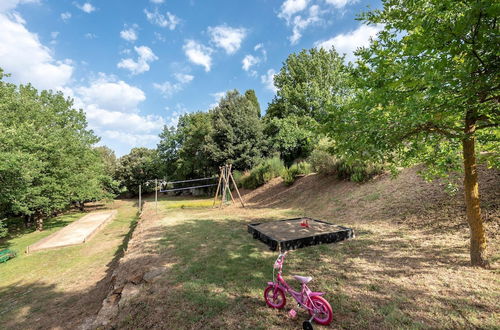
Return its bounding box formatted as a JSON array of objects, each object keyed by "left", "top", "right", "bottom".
[{"left": 0, "top": 201, "right": 137, "bottom": 328}]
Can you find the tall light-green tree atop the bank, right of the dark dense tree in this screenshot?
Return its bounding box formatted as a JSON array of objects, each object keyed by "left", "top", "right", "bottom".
[{"left": 265, "top": 48, "right": 351, "bottom": 165}]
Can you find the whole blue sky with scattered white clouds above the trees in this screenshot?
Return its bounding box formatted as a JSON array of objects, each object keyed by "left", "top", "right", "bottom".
[{"left": 0, "top": 0, "right": 381, "bottom": 156}]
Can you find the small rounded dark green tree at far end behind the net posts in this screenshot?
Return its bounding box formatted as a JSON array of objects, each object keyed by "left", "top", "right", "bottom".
[{"left": 117, "top": 148, "right": 161, "bottom": 195}]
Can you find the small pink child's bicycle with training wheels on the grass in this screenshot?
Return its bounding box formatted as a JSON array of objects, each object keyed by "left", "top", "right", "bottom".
[{"left": 264, "top": 251, "right": 333, "bottom": 330}]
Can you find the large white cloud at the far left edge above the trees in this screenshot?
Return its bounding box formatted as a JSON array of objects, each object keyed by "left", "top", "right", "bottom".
[{"left": 0, "top": 12, "right": 74, "bottom": 89}]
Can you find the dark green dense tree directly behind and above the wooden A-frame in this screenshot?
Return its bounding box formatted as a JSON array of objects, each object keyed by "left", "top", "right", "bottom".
[{"left": 207, "top": 90, "right": 264, "bottom": 170}]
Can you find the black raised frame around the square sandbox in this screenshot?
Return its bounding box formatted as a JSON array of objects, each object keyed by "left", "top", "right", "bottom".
[{"left": 247, "top": 217, "right": 354, "bottom": 251}]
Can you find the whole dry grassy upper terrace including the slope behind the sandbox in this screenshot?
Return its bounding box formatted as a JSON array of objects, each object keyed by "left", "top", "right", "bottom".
[{"left": 102, "top": 169, "right": 500, "bottom": 329}]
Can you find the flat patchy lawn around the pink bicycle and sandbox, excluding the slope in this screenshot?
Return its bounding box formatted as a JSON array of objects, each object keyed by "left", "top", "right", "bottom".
[{"left": 117, "top": 198, "right": 499, "bottom": 329}]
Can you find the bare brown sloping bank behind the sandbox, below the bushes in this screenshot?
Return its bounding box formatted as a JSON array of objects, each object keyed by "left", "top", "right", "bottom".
[{"left": 244, "top": 167, "right": 500, "bottom": 255}]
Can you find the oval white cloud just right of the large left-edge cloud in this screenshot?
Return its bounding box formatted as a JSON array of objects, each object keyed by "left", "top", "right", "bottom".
[{"left": 76, "top": 74, "right": 146, "bottom": 112}]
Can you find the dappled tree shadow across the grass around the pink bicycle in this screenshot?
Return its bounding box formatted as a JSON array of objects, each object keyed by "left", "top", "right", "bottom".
[{"left": 108, "top": 214, "right": 493, "bottom": 329}]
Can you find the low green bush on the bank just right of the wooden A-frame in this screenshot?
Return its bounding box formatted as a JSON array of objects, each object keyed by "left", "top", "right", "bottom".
[{"left": 239, "top": 157, "right": 285, "bottom": 189}]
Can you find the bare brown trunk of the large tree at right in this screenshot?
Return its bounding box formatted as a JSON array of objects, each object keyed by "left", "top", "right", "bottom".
[{"left": 462, "top": 111, "right": 488, "bottom": 267}]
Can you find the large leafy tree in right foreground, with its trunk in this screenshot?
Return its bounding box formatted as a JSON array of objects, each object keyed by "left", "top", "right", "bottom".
[{"left": 327, "top": 0, "right": 500, "bottom": 266}]
